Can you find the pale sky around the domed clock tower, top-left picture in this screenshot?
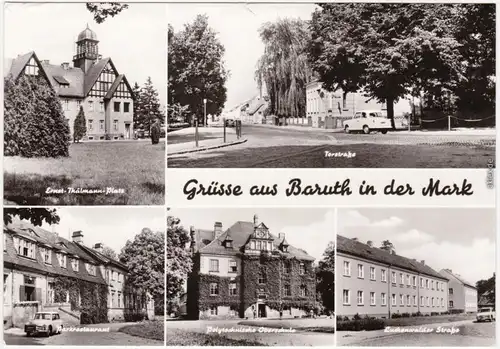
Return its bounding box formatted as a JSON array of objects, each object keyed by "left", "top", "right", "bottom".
[{"left": 4, "top": 3, "right": 167, "bottom": 106}]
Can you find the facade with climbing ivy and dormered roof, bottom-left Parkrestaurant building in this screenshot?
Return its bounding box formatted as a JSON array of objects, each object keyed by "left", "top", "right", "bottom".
[{"left": 3, "top": 221, "right": 154, "bottom": 328}]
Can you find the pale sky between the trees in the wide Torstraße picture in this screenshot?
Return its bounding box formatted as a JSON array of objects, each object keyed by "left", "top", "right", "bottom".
[{"left": 167, "top": 3, "right": 315, "bottom": 110}]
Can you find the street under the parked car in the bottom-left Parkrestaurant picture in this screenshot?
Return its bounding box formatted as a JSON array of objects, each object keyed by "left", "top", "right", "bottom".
[{"left": 3, "top": 323, "right": 163, "bottom": 346}]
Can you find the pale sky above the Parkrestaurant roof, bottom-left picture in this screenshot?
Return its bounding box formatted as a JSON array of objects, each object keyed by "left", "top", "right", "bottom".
[{"left": 38, "top": 206, "right": 166, "bottom": 254}]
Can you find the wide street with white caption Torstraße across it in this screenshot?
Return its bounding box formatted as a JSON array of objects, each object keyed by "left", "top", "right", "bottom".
[{"left": 167, "top": 125, "right": 495, "bottom": 168}]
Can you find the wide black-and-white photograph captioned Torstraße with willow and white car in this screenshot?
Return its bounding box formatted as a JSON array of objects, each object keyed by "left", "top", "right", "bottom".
[{"left": 167, "top": 3, "right": 496, "bottom": 169}]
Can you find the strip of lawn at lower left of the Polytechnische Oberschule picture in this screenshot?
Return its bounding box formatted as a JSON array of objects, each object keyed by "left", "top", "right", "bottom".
[{"left": 167, "top": 328, "right": 266, "bottom": 347}]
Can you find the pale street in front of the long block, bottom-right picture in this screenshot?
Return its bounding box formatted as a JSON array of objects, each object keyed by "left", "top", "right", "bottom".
[{"left": 337, "top": 320, "right": 496, "bottom": 347}]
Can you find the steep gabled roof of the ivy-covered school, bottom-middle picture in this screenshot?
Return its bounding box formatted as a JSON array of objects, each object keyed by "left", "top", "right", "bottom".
[{"left": 200, "top": 221, "right": 315, "bottom": 261}]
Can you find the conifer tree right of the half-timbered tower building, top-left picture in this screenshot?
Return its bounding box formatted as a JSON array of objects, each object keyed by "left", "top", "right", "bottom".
[{"left": 133, "top": 77, "right": 165, "bottom": 132}]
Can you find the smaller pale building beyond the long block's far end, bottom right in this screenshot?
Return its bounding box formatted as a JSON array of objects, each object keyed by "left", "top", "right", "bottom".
[{"left": 439, "top": 269, "right": 478, "bottom": 313}]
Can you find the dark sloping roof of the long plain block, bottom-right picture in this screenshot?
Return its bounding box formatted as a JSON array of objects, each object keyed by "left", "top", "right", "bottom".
[{"left": 337, "top": 235, "right": 448, "bottom": 280}]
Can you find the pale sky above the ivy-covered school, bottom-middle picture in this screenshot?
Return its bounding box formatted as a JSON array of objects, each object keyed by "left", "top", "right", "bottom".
[{"left": 168, "top": 208, "right": 335, "bottom": 263}]
